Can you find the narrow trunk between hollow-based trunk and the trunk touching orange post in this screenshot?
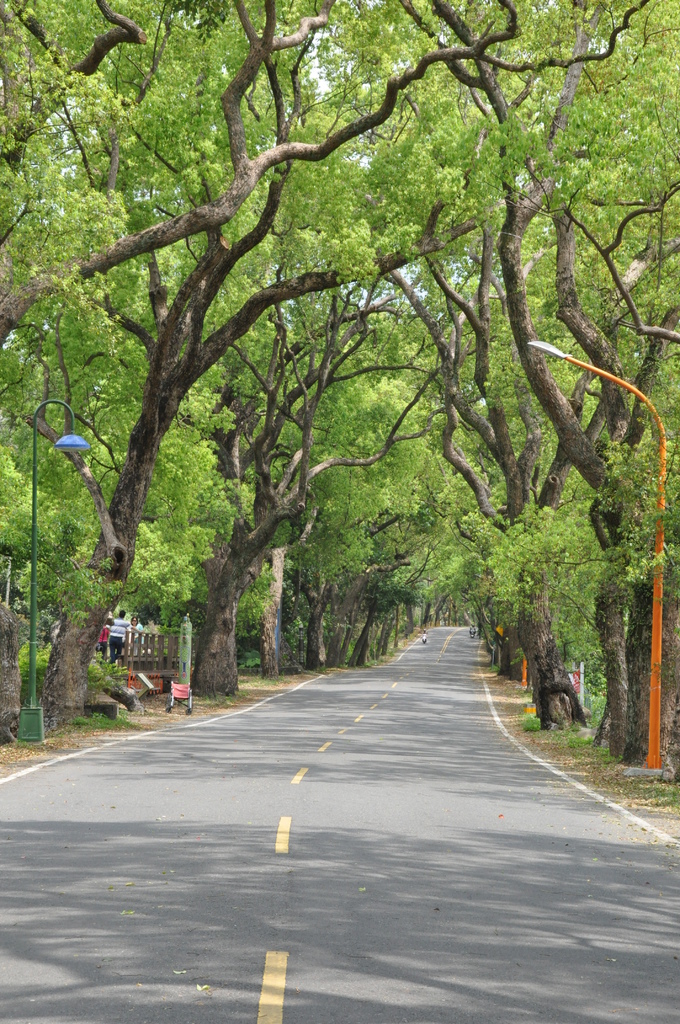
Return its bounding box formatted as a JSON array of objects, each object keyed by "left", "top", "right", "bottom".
[{"left": 595, "top": 581, "right": 628, "bottom": 758}]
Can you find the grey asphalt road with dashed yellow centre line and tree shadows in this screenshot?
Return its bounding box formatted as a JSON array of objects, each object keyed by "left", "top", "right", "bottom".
[{"left": 0, "top": 629, "right": 680, "bottom": 1024}]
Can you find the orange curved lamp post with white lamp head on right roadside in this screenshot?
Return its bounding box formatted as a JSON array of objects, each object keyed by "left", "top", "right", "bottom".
[{"left": 528, "top": 341, "right": 666, "bottom": 768}]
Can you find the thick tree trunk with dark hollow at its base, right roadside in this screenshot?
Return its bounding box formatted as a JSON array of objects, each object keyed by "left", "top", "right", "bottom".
[{"left": 518, "top": 586, "right": 586, "bottom": 729}]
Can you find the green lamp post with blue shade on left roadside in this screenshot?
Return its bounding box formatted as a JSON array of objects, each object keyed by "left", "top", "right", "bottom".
[{"left": 16, "top": 398, "right": 90, "bottom": 743}]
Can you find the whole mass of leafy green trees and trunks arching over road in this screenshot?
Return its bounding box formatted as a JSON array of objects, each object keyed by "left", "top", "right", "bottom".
[{"left": 0, "top": 0, "right": 680, "bottom": 774}]
